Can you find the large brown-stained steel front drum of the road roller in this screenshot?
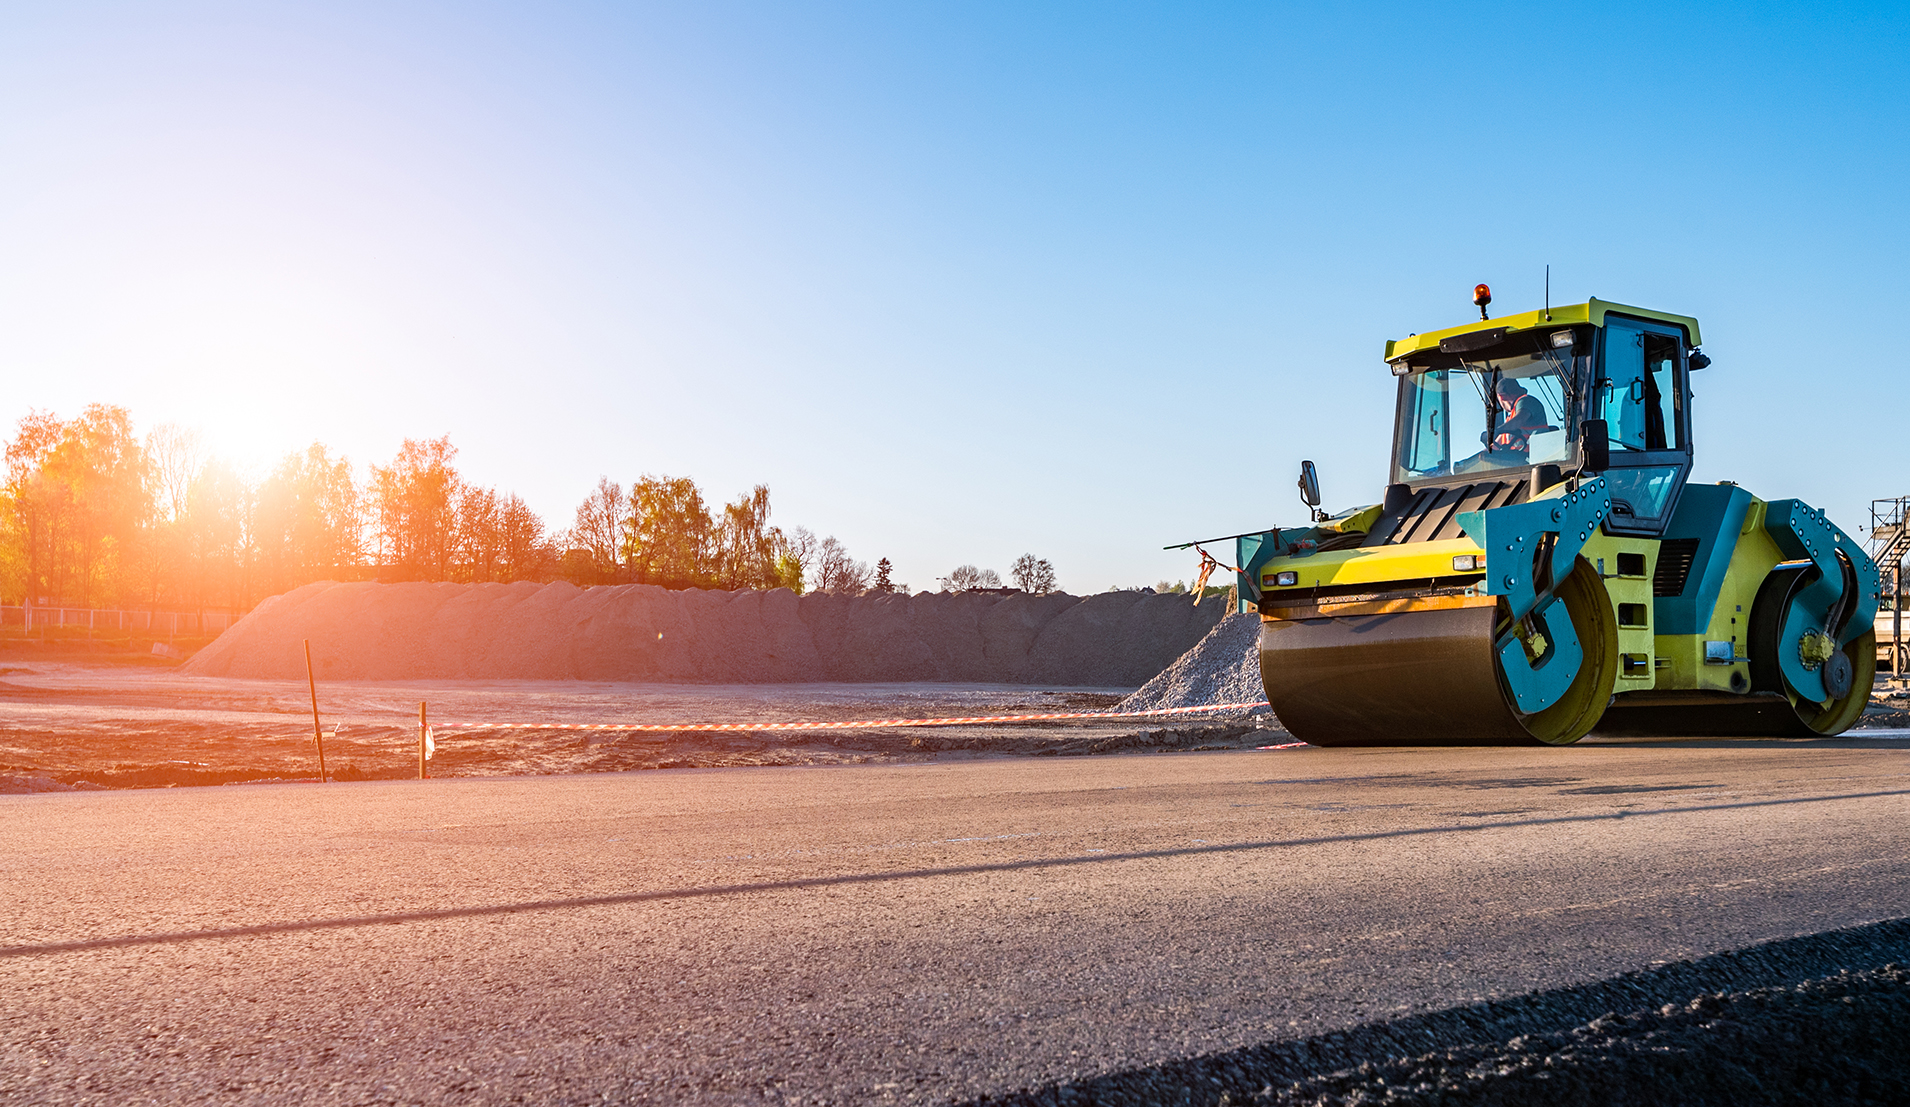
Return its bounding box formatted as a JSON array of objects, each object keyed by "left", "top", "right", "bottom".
[{"left": 1261, "top": 557, "right": 1618, "bottom": 746}]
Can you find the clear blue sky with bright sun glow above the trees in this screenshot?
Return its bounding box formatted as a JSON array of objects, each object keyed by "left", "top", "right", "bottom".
[{"left": 0, "top": 0, "right": 1910, "bottom": 592}]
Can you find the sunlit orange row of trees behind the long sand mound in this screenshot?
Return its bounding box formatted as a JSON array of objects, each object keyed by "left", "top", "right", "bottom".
[{"left": 0, "top": 405, "right": 894, "bottom": 611}]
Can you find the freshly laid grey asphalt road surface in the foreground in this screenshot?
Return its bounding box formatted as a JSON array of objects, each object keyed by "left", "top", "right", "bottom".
[{"left": 0, "top": 737, "right": 1910, "bottom": 1103}]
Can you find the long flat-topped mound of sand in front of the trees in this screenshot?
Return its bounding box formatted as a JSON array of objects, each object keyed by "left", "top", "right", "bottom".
[{"left": 183, "top": 582, "right": 1224, "bottom": 687}]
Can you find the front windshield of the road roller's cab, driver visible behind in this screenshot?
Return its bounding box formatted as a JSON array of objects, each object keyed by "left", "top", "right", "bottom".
[{"left": 1392, "top": 349, "right": 1572, "bottom": 483}]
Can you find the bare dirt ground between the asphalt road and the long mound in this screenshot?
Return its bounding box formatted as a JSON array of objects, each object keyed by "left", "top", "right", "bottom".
[{"left": 0, "top": 658, "right": 1289, "bottom": 792}]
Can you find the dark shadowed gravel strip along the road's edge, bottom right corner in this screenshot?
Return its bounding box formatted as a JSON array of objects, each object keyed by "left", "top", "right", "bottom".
[{"left": 976, "top": 918, "right": 1910, "bottom": 1107}]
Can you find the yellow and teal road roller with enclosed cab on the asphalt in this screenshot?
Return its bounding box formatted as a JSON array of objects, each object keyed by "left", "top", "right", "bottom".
[{"left": 1188, "top": 293, "right": 1879, "bottom": 746}]
